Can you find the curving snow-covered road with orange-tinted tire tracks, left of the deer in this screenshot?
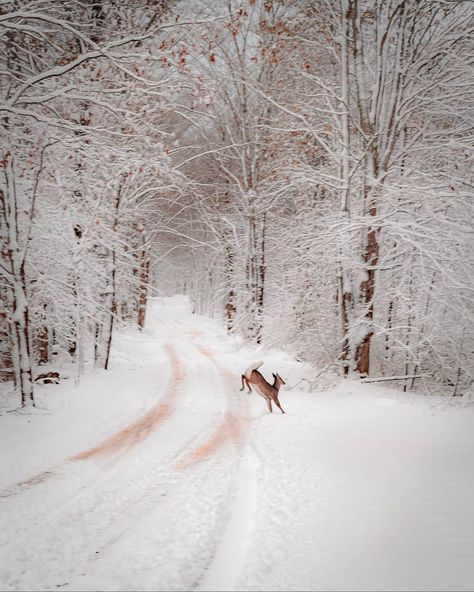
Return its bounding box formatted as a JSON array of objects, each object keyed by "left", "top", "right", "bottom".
[{"left": 0, "top": 312, "right": 256, "bottom": 590}]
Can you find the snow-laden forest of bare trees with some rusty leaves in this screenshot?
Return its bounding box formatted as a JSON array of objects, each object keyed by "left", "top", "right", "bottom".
[{"left": 0, "top": 0, "right": 474, "bottom": 406}]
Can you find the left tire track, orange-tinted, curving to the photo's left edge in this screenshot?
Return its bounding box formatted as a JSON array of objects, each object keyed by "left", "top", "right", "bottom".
[{"left": 0, "top": 343, "right": 184, "bottom": 498}]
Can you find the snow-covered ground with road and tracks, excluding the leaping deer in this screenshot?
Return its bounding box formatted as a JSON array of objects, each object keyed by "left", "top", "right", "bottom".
[{"left": 0, "top": 297, "right": 474, "bottom": 590}]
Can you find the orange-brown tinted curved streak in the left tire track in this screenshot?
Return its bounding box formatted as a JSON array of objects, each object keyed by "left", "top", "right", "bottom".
[{"left": 69, "top": 344, "right": 183, "bottom": 460}]
